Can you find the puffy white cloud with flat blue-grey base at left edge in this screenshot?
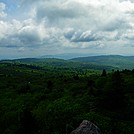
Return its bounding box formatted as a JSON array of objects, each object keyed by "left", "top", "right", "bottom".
[{"left": 0, "top": 20, "right": 50, "bottom": 47}]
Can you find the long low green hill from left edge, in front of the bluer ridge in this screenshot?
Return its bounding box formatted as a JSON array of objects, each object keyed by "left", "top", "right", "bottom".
[{"left": 1, "top": 58, "right": 117, "bottom": 70}]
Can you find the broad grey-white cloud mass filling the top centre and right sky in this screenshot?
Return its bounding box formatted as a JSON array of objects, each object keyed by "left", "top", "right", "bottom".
[{"left": 31, "top": 0, "right": 131, "bottom": 31}]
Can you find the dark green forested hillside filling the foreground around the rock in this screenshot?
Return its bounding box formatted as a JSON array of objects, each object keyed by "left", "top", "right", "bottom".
[{"left": 0, "top": 60, "right": 134, "bottom": 134}]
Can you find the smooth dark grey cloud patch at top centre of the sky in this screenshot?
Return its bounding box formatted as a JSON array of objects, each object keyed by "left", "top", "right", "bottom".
[{"left": 35, "top": 1, "right": 87, "bottom": 23}]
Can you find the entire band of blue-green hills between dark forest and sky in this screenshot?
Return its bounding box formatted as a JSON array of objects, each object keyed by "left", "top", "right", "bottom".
[{"left": 1, "top": 55, "right": 134, "bottom": 70}]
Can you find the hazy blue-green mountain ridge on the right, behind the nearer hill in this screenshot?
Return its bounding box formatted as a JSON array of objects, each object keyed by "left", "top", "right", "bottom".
[{"left": 70, "top": 55, "right": 134, "bottom": 69}]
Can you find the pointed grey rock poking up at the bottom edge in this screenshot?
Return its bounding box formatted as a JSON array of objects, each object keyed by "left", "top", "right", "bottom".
[{"left": 71, "top": 120, "right": 102, "bottom": 134}]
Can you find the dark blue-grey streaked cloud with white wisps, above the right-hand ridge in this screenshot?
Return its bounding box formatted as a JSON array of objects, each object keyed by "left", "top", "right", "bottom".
[{"left": 64, "top": 29, "right": 120, "bottom": 42}]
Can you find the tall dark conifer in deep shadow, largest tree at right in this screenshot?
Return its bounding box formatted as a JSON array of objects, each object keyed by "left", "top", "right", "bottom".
[{"left": 103, "top": 71, "right": 126, "bottom": 111}]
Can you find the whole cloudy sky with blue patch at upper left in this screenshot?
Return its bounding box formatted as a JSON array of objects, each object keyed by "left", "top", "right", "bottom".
[{"left": 0, "top": 0, "right": 134, "bottom": 59}]
